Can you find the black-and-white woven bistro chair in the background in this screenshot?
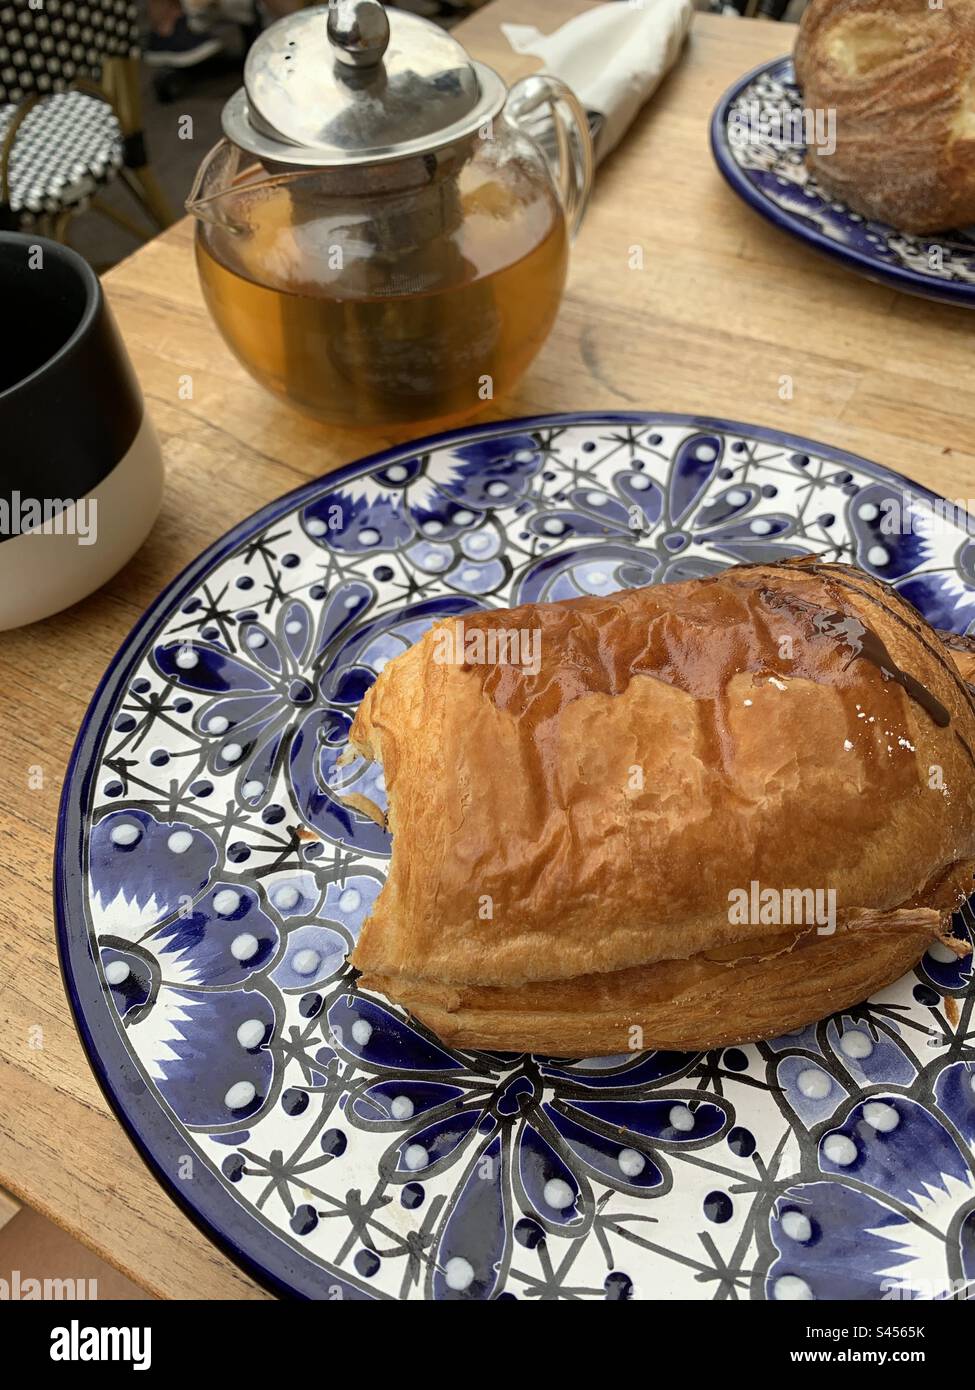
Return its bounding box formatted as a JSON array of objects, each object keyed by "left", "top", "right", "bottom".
[{"left": 0, "top": 0, "right": 171, "bottom": 240}]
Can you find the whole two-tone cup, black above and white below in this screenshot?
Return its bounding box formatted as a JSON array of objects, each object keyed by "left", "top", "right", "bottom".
[{"left": 0, "top": 232, "right": 163, "bottom": 630}]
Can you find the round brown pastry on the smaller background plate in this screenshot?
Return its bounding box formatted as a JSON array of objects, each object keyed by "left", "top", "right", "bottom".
[{"left": 796, "top": 0, "right": 975, "bottom": 232}]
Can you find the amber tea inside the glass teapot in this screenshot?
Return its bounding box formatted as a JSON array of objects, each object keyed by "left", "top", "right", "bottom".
[{"left": 196, "top": 165, "right": 567, "bottom": 427}]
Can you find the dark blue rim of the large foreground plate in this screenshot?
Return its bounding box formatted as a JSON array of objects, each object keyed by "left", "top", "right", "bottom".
[{"left": 53, "top": 410, "right": 975, "bottom": 1301}]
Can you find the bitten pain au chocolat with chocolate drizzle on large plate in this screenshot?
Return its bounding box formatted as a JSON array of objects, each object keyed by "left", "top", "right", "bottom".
[{"left": 350, "top": 560, "right": 975, "bottom": 1056}]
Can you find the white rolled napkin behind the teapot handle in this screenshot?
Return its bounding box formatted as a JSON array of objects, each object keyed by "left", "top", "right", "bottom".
[{"left": 501, "top": 0, "right": 694, "bottom": 160}]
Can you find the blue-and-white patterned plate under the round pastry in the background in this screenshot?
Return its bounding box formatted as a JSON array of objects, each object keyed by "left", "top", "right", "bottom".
[{"left": 711, "top": 58, "right": 975, "bottom": 306}]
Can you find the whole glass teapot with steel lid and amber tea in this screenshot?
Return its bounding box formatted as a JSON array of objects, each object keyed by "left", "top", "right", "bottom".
[{"left": 186, "top": 0, "right": 593, "bottom": 427}]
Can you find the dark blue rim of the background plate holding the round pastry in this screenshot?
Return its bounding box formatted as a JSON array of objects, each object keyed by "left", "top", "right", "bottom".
[{"left": 711, "top": 54, "right": 975, "bottom": 307}]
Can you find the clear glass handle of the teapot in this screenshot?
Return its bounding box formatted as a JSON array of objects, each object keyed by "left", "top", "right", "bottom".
[{"left": 505, "top": 72, "right": 594, "bottom": 238}]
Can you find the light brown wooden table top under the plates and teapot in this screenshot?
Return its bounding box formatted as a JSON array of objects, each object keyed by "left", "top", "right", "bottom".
[{"left": 0, "top": 0, "right": 975, "bottom": 1298}]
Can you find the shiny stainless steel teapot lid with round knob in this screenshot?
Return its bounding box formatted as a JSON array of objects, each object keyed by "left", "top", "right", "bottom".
[{"left": 223, "top": 0, "right": 506, "bottom": 168}]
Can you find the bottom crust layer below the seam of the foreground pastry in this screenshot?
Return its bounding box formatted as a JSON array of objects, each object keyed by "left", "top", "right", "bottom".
[{"left": 360, "top": 909, "right": 942, "bottom": 1056}]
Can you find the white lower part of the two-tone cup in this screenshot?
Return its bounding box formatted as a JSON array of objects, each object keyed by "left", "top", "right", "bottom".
[{"left": 0, "top": 414, "right": 163, "bottom": 631}]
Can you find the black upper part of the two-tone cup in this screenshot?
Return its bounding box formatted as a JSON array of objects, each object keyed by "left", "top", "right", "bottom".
[{"left": 0, "top": 232, "right": 143, "bottom": 514}]
